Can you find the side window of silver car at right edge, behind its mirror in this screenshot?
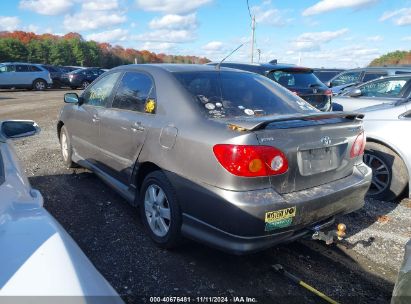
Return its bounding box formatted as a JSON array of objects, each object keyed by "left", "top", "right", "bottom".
[{"left": 360, "top": 78, "right": 410, "bottom": 98}]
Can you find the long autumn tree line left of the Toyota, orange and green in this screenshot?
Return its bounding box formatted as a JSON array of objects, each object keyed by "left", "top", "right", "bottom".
[{"left": 0, "top": 31, "right": 209, "bottom": 68}]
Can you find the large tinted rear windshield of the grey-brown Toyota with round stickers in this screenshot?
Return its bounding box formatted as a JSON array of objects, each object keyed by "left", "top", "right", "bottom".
[{"left": 174, "top": 71, "right": 317, "bottom": 118}]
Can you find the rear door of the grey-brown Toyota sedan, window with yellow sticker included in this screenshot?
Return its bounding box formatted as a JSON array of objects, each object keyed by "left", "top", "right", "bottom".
[{"left": 100, "top": 72, "right": 156, "bottom": 183}]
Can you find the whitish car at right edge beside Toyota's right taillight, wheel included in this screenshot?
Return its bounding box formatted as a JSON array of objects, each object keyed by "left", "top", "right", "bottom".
[{"left": 356, "top": 100, "right": 411, "bottom": 201}]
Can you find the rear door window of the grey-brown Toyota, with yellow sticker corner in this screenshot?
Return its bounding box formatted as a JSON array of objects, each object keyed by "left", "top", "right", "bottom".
[{"left": 112, "top": 72, "right": 155, "bottom": 113}]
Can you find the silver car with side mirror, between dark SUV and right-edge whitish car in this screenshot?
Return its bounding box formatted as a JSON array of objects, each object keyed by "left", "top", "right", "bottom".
[{"left": 333, "top": 74, "right": 411, "bottom": 111}]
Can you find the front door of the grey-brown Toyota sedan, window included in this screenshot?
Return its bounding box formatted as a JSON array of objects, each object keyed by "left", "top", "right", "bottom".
[{"left": 66, "top": 72, "right": 121, "bottom": 165}]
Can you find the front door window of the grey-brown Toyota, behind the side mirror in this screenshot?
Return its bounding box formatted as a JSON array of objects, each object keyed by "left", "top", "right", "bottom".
[{"left": 82, "top": 72, "right": 121, "bottom": 107}]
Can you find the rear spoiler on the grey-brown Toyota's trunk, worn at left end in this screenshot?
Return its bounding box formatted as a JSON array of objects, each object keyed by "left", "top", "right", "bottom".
[{"left": 228, "top": 112, "right": 364, "bottom": 131}]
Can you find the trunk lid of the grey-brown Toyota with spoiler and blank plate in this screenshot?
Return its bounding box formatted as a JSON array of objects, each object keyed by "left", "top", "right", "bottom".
[{"left": 225, "top": 112, "right": 363, "bottom": 193}]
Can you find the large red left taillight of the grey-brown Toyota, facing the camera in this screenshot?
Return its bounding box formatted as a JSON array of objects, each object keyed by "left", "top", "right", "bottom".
[{"left": 213, "top": 144, "right": 288, "bottom": 177}]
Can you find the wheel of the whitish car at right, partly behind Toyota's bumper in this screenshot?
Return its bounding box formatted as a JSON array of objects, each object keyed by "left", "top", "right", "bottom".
[{"left": 364, "top": 142, "right": 408, "bottom": 201}]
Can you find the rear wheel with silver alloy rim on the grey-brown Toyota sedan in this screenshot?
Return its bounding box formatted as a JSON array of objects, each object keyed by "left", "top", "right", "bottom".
[{"left": 140, "top": 171, "right": 181, "bottom": 249}]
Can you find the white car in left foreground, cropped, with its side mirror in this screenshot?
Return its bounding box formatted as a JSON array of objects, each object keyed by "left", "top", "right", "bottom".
[{"left": 0, "top": 121, "right": 122, "bottom": 303}]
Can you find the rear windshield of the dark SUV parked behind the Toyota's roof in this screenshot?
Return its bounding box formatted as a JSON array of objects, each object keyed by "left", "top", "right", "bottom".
[{"left": 267, "top": 70, "right": 323, "bottom": 89}]
